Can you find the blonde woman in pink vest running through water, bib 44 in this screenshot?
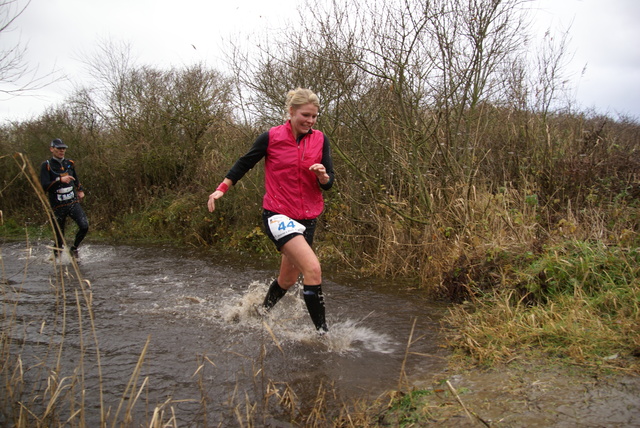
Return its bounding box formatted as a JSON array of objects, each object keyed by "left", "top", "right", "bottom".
[{"left": 208, "top": 88, "right": 334, "bottom": 333}]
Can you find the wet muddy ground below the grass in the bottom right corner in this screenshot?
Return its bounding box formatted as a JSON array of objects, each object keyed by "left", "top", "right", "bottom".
[{"left": 380, "top": 363, "right": 640, "bottom": 428}]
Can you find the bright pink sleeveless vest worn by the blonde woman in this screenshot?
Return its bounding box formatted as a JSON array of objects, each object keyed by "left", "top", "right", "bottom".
[{"left": 262, "top": 122, "right": 324, "bottom": 220}]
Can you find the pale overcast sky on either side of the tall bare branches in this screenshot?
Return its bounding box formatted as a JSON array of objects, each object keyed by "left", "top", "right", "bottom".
[{"left": 0, "top": 0, "right": 640, "bottom": 122}]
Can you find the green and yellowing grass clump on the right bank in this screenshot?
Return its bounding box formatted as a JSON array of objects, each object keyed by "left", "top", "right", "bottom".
[{"left": 449, "top": 240, "right": 640, "bottom": 371}]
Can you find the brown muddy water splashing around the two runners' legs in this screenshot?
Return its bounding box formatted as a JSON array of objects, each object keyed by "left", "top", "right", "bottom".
[{"left": 0, "top": 243, "right": 445, "bottom": 426}]
